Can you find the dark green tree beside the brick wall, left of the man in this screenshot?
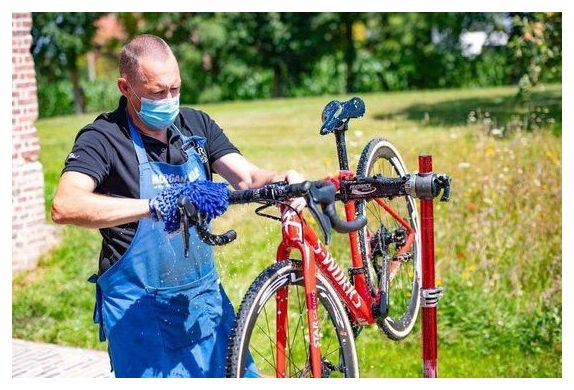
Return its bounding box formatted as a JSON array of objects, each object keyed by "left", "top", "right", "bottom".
[{"left": 31, "top": 12, "right": 103, "bottom": 113}]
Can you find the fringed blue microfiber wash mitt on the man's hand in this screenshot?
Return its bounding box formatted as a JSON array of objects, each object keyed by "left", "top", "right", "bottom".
[{"left": 156, "top": 180, "right": 233, "bottom": 233}]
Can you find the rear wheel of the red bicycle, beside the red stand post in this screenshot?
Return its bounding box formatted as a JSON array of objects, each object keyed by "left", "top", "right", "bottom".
[{"left": 357, "top": 138, "right": 421, "bottom": 340}]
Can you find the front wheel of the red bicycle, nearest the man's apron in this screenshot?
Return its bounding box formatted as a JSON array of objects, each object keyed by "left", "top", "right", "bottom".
[{"left": 226, "top": 260, "right": 359, "bottom": 378}]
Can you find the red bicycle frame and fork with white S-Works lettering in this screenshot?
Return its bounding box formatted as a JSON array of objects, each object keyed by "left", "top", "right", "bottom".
[{"left": 276, "top": 170, "right": 415, "bottom": 378}]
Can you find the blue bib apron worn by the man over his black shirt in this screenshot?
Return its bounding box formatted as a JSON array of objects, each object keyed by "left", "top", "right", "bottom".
[{"left": 91, "top": 117, "right": 258, "bottom": 377}]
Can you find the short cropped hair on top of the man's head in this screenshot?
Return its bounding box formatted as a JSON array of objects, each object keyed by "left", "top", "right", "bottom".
[{"left": 120, "top": 34, "right": 173, "bottom": 81}]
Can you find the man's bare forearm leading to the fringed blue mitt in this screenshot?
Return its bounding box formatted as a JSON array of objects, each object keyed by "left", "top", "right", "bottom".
[{"left": 52, "top": 193, "right": 149, "bottom": 229}]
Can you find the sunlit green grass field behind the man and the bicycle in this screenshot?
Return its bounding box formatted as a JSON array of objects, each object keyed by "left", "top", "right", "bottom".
[{"left": 12, "top": 85, "right": 562, "bottom": 377}]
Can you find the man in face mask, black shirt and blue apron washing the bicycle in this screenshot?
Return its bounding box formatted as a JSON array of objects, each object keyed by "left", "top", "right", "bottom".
[{"left": 52, "top": 35, "right": 304, "bottom": 377}]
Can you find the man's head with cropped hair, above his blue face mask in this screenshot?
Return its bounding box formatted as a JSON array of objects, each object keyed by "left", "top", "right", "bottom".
[{"left": 117, "top": 34, "right": 181, "bottom": 131}]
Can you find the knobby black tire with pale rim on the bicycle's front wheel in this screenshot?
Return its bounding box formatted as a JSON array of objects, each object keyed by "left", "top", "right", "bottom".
[{"left": 226, "top": 260, "right": 359, "bottom": 378}]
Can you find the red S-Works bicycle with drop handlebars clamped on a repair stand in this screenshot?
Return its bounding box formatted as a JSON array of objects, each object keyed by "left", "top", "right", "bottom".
[{"left": 180, "top": 98, "right": 450, "bottom": 378}]
